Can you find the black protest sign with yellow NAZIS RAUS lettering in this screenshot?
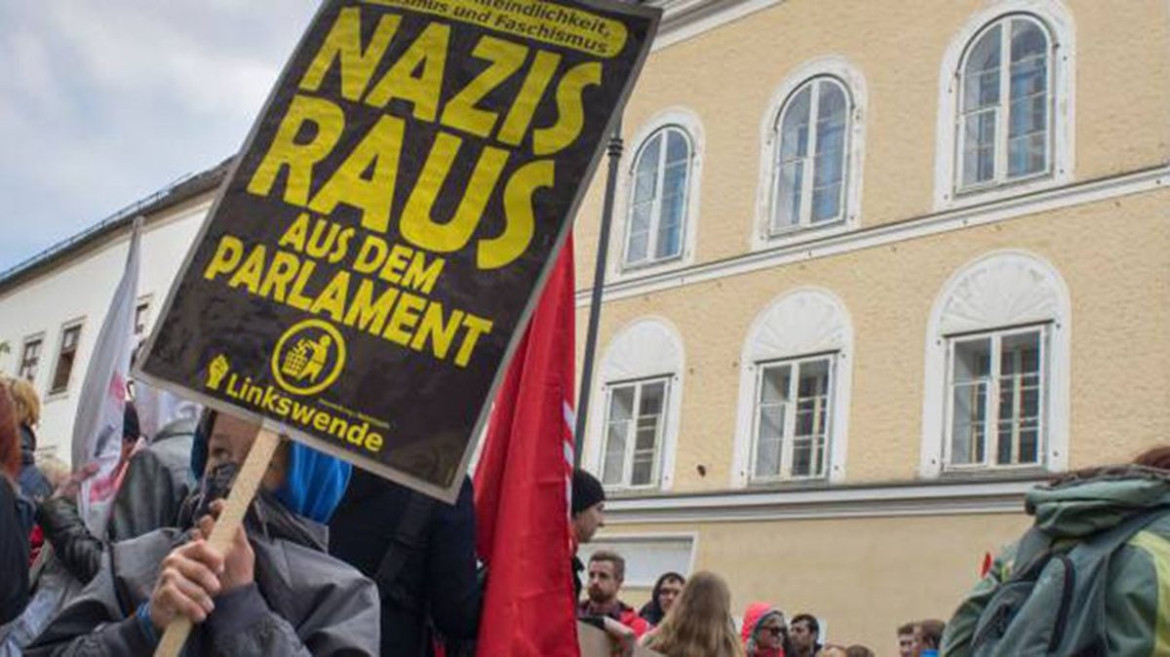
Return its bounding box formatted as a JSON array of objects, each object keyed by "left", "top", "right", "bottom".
[{"left": 139, "top": 0, "right": 659, "bottom": 499}]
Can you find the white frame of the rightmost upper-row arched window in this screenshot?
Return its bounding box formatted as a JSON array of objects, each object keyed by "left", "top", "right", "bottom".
[{"left": 955, "top": 13, "right": 1057, "bottom": 194}]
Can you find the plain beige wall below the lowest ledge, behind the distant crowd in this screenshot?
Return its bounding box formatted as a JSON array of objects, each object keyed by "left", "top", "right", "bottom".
[{"left": 605, "top": 513, "right": 1030, "bottom": 655}]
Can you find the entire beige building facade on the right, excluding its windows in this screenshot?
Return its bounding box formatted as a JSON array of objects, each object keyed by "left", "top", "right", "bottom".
[{"left": 574, "top": 0, "right": 1170, "bottom": 655}]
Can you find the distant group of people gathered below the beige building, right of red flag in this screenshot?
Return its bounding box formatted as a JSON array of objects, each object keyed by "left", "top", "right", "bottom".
[{"left": 572, "top": 470, "right": 944, "bottom": 657}]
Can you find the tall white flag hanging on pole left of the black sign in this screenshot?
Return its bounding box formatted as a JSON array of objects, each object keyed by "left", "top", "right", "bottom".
[{"left": 73, "top": 217, "right": 143, "bottom": 538}]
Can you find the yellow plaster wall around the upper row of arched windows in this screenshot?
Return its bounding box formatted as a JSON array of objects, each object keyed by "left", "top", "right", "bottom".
[{"left": 577, "top": 0, "right": 1170, "bottom": 278}]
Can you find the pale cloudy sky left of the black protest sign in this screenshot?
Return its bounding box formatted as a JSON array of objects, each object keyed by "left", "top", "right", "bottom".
[{"left": 0, "top": 0, "right": 317, "bottom": 271}]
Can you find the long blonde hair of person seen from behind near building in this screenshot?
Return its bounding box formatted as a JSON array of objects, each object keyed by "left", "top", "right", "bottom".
[{"left": 647, "top": 570, "right": 744, "bottom": 657}]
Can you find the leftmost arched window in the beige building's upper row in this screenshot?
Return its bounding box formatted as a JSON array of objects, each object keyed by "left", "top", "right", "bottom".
[{"left": 622, "top": 125, "right": 694, "bottom": 268}]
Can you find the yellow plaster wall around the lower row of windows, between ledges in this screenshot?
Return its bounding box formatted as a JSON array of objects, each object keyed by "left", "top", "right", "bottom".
[{"left": 578, "top": 191, "right": 1170, "bottom": 491}]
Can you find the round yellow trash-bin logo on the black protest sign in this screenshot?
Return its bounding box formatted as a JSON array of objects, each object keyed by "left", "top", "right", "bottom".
[{"left": 273, "top": 319, "right": 345, "bottom": 395}]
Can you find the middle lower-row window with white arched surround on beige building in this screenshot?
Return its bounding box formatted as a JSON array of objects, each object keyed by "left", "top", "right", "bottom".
[{"left": 731, "top": 289, "right": 853, "bottom": 487}]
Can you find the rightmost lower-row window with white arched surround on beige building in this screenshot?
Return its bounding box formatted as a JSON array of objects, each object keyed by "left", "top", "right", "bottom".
[{"left": 922, "top": 251, "right": 1069, "bottom": 476}]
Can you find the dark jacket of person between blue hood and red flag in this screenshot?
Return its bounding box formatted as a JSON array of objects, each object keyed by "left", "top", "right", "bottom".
[{"left": 329, "top": 469, "right": 480, "bottom": 657}]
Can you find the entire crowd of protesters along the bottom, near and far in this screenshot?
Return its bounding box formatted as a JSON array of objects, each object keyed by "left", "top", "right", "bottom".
[{"left": 0, "top": 369, "right": 1170, "bottom": 657}]
